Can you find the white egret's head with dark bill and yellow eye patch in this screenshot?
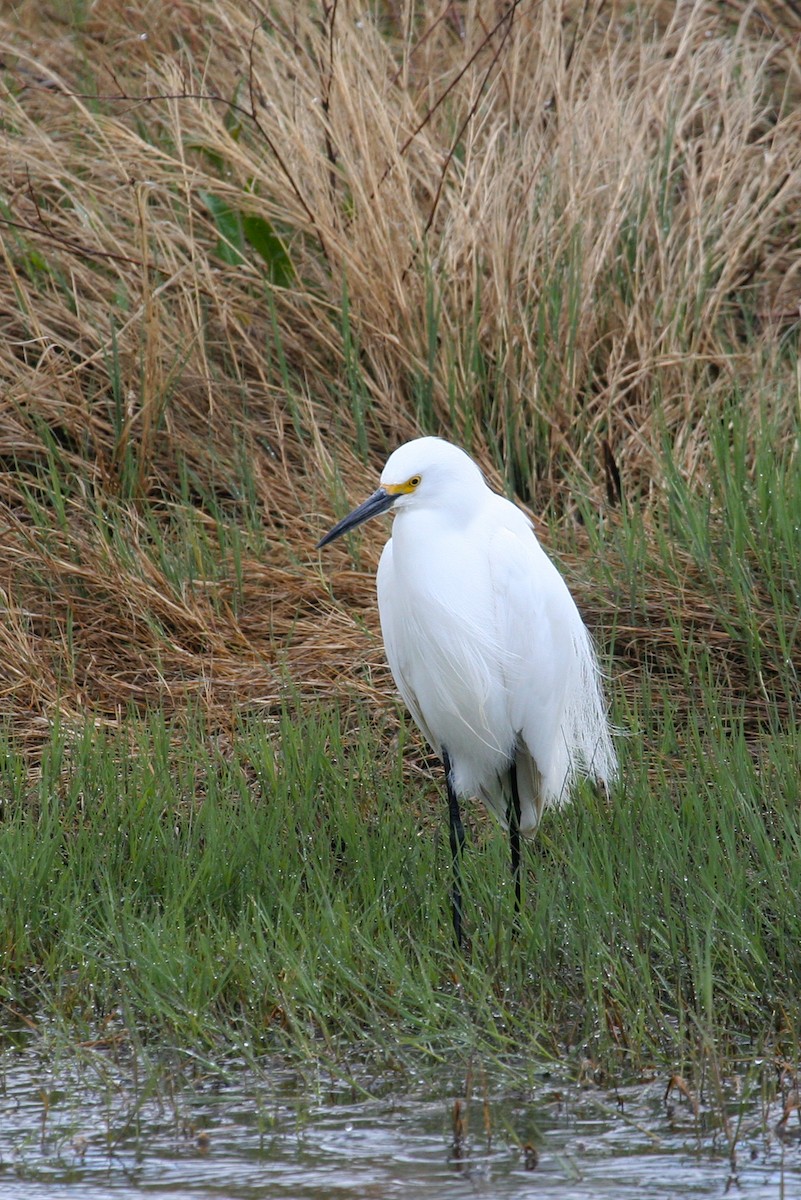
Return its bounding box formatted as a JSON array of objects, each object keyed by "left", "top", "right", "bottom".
[{"left": 317, "top": 438, "right": 486, "bottom": 550}]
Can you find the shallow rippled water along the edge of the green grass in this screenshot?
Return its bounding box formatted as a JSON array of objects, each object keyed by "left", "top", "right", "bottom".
[{"left": 0, "top": 1050, "right": 801, "bottom": 1200}]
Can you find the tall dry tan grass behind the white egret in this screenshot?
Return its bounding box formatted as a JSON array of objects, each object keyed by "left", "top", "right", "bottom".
[{"left": 0, "top": 0, "right": 801, "bottom": 743}]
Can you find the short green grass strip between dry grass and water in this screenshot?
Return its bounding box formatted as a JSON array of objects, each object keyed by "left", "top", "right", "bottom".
[{"left": 0, "top": 652, "right": 801, "bottom": 1064}]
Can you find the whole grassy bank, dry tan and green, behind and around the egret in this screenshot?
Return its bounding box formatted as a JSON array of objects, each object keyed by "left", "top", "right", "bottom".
[{"left": 0, "top": 0, "right": 801, "bottom": 1062}]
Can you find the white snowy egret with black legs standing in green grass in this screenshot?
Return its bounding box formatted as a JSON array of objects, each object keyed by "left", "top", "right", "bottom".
[{"left": 318, "top": 438, "right": 616, "bottom": 944}]
